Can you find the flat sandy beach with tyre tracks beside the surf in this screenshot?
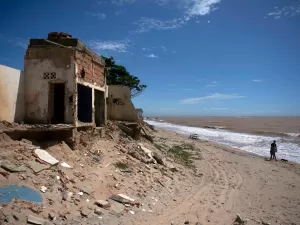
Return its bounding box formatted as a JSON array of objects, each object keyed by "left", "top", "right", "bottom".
[{"left": 141, "top": 130, "right": 300, "bottom": 225}]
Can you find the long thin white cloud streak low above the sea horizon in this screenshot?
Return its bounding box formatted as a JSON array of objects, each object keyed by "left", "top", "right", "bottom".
[{"left": 180, "top": 93, "right": 245, "bottom": 104}]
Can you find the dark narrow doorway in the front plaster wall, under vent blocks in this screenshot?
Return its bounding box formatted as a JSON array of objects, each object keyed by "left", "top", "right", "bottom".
[{"left": 49, "top": 83, "right": 65, "bottom": 124}]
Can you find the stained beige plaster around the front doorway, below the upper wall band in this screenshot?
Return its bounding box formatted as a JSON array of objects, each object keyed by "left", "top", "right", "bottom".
[{"left": 24, "top": 57, "right": 75, "bottom": 124}]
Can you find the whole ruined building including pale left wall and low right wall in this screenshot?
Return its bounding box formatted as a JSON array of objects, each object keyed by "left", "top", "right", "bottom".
[{"left": 0, "top": 32, "right": 143, "bottom": 146}]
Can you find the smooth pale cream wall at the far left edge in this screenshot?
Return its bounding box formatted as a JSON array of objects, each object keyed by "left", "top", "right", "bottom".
[{"left": 0, "top": 65, "right": 24, "bottom": 122}]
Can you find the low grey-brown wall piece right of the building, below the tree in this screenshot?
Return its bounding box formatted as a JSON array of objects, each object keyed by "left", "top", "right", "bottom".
[{"left": 107, "top": 85, "right": 138, "bottom": 121}]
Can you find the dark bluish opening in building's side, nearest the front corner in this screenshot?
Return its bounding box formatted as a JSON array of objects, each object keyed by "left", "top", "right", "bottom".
[{"left": 77, "top": 84, "right": 93, "bottom": 123}]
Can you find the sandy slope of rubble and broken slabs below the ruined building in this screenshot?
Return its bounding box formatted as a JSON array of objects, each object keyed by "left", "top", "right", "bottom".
[{"left": 0, "top": 122, "right": 202, "bottom": 225}]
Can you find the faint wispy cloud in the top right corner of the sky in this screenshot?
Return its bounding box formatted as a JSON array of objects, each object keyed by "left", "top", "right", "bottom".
[{"left": 266, "top": 1, "right": 300, "bottom": 20}]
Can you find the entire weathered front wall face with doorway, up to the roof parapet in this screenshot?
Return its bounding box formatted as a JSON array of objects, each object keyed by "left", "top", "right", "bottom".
[{"left": 24, "top": 47, "right": 76, "bottom": 124}]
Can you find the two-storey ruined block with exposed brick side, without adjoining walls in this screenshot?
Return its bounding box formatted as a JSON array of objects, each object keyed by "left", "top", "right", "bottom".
[{"left": 24, "top": 33, "right": 107, "bottom": 127}]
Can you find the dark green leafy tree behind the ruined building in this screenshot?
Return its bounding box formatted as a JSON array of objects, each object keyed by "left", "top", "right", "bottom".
[{"left": 102, "top": 56, "right": 147, "bottom": 98}]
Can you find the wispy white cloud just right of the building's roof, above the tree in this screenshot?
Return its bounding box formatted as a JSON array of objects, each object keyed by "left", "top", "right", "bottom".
[{"left": 88, "top": 40, "right": 129, "bottom": 52}]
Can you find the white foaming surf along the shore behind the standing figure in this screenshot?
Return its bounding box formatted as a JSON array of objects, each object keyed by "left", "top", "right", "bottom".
[{"left": 145, "top": 120, "right": 300, "bottom": 163}]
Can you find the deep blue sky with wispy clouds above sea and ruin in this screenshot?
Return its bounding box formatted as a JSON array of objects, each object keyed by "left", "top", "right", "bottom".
[{"left": 0, "top": 0, "right": 300, "bottom": 116}]
